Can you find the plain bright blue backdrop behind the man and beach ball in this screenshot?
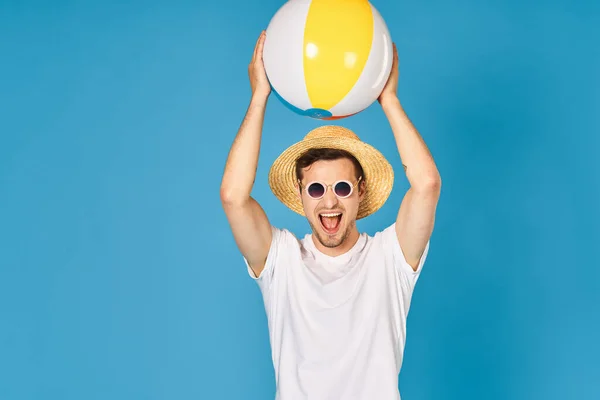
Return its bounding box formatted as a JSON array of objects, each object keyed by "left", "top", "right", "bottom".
[{"left": 0, "top": 0, "right": 600, "bottom": 400}]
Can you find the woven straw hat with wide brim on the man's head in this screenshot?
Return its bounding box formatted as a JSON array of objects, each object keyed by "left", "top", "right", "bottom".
[{"left": 269, "top": 125, "right": 394, "bottom": 219}]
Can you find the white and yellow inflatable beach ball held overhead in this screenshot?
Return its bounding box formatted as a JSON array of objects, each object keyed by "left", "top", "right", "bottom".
[{"left": 263, "top": 0, "right": 393, "bottom": 120}]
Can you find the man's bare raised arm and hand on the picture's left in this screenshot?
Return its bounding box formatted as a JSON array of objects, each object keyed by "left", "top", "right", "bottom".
[{"left": 221, "top": 32, "right": 271, "bottom": 276}]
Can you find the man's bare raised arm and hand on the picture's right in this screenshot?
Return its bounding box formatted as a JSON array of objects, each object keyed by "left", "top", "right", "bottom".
[{"left": 379, "top": 45, "right": 442, "bottom": 270}]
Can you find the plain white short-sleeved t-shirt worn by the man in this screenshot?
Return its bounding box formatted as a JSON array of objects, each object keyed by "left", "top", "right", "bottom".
[{"left": 246, "top": 225, "right": 429, "bottom": 400}]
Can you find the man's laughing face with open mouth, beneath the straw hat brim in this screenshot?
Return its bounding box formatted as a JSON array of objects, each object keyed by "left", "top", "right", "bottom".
[{"left": 299, "top": 158, "right": 364, "bottom": 247}]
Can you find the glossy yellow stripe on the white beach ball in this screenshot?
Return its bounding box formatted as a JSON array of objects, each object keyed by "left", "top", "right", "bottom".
[{"left": 303, "top": 0, "right": 373, "bottom": 110}]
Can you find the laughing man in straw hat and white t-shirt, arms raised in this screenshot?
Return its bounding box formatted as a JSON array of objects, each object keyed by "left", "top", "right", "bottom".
[{"left": 221, "top": 32, "right": 441, "bottom": 400}]
